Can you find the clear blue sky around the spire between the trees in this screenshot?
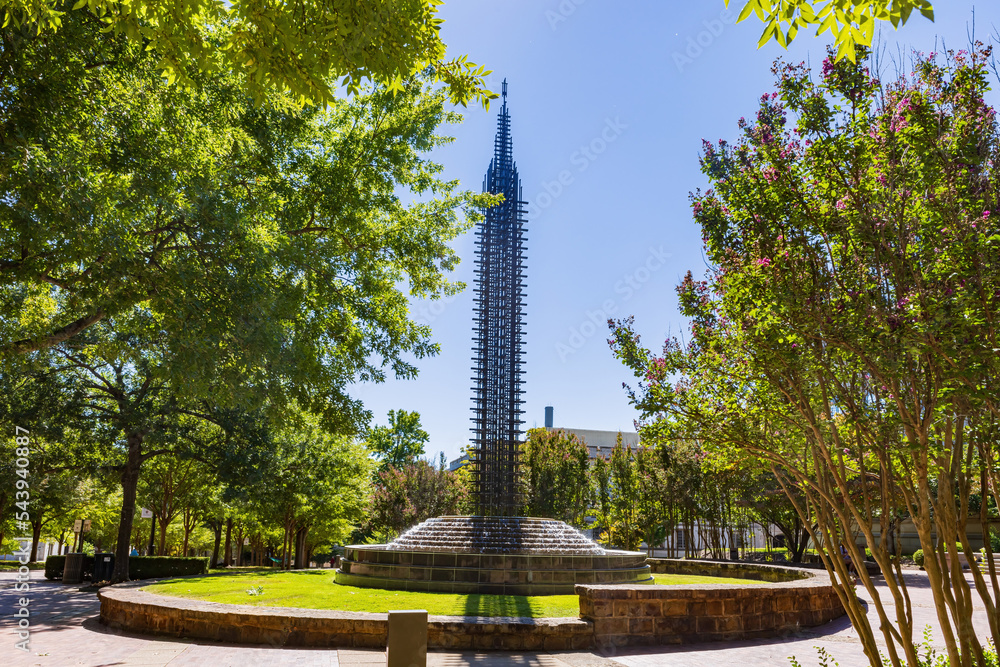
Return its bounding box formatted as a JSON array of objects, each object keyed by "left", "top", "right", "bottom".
[{"left": 353, "top": 0, "right": 1000, "bottom": 459}]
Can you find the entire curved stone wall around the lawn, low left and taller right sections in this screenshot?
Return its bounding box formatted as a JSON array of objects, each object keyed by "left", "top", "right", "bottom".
[{"left": 99, "top": 559, "right": 845, "bottom": 651}]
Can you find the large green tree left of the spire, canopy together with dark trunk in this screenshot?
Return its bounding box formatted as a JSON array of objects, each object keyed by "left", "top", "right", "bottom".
[{"left": 0, "top": 12, "right": 493, "bottom": 579}]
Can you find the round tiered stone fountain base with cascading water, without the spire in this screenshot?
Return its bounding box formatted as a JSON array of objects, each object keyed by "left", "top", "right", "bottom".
[{"left": 336, "top": 517, "right": 653, "bottom": 595}]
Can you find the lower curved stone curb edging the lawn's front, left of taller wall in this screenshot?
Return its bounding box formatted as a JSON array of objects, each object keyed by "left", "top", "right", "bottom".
[{"left": 98, "top": 577, "right": 594, "bottom": 650}]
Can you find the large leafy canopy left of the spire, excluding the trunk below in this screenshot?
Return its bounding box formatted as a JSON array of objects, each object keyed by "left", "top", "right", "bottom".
[{"left": 0, "top": 12, "right": 486, "bottom": 366}]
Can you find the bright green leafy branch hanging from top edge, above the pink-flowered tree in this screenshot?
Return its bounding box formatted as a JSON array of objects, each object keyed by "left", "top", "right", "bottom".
[{"left": 726, "top": 0, "right": 934, "bottom": 61}]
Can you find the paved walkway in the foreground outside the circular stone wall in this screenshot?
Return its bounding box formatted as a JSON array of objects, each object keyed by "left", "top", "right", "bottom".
[{"left": 0, "top": 572, "right": 989, "bottom": 667}]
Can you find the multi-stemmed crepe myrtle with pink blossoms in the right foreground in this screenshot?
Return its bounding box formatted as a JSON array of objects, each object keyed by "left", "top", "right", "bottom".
[{"left": 612, "top": 45, "right": 1000, "bottom": 666}]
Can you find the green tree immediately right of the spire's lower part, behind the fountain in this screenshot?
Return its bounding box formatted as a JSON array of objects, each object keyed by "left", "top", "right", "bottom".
[{"left": 521, "top": 428, "right": 593, "bottom": 527}]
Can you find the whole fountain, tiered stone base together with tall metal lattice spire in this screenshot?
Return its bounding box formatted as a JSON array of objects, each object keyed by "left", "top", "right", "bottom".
[{"left": 336, "top": 80, "right": 652, "bottom": 595}]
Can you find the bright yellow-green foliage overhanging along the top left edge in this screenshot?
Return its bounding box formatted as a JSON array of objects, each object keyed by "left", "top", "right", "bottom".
[{"left": 0, "top": 0, "right": 496, "bottom": 104}]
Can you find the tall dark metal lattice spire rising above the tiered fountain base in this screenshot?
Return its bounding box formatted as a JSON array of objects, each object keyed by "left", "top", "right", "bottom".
[{"left": 471, "top": 80, "right": 527, "bottom": 517}]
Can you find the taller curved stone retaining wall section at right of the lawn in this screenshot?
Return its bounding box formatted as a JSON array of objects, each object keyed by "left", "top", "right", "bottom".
[{"left": 576, "top": 559, "right": 845, "bottom": 647}]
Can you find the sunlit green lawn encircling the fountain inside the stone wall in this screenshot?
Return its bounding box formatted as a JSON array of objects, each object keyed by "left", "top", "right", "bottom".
[{"left": 145, "top": 570, "right": 755, "bottom": 618}]
